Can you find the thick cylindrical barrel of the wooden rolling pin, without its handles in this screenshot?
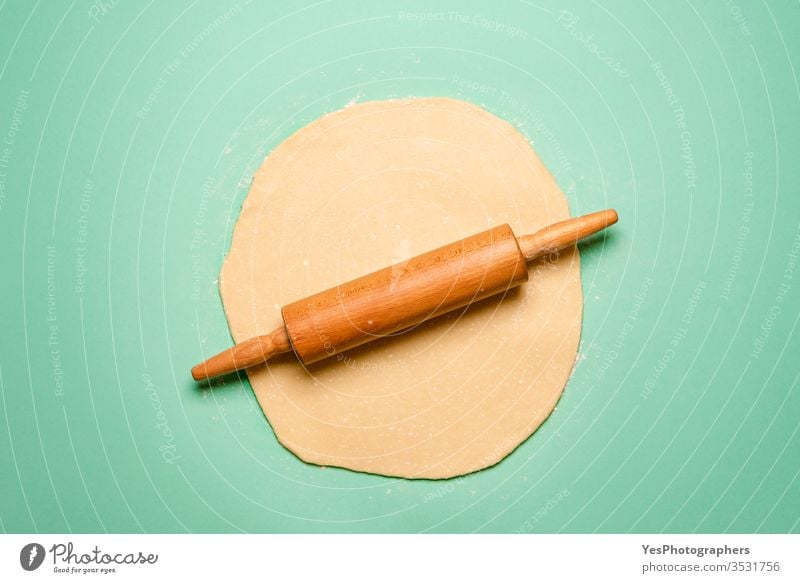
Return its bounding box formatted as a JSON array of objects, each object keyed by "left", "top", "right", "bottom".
[{"left": 283, "top": 225, "right": 528, "bottom": 364}]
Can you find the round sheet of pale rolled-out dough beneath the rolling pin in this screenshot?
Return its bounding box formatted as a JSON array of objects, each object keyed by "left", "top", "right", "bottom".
[{"left": 220, "top": 98, "right": 582, "bottom": 478}]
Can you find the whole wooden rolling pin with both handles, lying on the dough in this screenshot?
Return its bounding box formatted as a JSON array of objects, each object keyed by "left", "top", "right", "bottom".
[{"left": 192, "top": 209, "right": 617, "bottom": 381}]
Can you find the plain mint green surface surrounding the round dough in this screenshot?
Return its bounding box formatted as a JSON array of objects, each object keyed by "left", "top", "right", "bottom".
[{"left": 0, "top": 0, "right": 800, "bottom": 532}]
